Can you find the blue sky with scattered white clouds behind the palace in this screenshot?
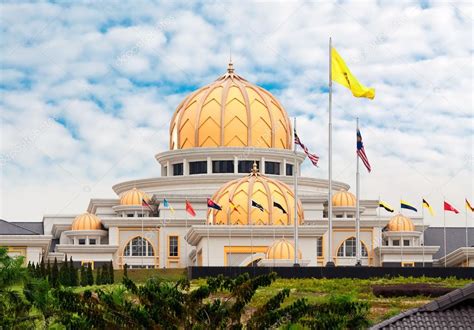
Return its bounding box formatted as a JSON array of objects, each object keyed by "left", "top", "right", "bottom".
[{"left": 0, "top": 1, "right": 474, "bottom": 226}]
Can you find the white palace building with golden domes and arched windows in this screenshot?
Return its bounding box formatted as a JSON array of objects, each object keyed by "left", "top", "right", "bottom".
[{"left": 0, "top": 64, "right": 474, "bottom": 269}]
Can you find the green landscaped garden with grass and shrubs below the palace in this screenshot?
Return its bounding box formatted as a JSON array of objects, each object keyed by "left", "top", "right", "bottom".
[{"left": 0, "top": 249, "right": 471, "bottom": 329}]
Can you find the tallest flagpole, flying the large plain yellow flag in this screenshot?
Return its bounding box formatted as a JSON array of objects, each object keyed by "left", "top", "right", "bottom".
[{"left": 326, "top": 37, "right": 335, "bottom": 266}]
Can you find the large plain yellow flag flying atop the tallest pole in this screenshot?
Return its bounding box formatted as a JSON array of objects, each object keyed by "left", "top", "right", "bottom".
[{"left": 331, "top": 48, "right": 375, "bottom": 100}]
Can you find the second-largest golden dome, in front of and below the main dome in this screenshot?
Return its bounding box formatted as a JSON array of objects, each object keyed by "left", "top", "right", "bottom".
[{"left": 208, "top": 164, "right": 303, "bottom": 225}]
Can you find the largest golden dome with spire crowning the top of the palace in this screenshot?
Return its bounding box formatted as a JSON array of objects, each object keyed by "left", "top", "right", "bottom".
[{"left": 170, "top": 63, "right": 291, "bottom": 150}]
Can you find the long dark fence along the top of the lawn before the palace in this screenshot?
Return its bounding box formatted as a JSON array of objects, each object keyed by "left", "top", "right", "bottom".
[{"left": 188, "top": 266, "right": 474, "bottom": 279}]
